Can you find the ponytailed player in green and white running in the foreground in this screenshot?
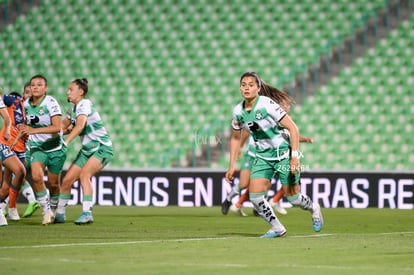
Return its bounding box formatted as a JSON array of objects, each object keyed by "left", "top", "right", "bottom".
[{"left": 225, "top": 72, "right": 323, "bottom": 238}]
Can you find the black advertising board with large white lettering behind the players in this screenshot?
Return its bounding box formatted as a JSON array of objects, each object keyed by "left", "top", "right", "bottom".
[{"left": 29, "top": 169, "right": 414, "bottom": 209}]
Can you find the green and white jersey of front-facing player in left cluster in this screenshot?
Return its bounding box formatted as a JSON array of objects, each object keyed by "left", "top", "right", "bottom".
[{"left": 24, "top": 95, "right": 63, "bottom": 152}]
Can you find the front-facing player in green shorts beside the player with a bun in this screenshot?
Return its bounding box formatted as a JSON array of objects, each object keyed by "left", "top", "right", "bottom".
[{"left": 19, "top": 75, "right": 67, "bottom": 225}]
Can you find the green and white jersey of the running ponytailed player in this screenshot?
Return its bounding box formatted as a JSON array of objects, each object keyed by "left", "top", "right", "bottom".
[{"left": 232, "top": 96, "right": 289, "bottom": 160}]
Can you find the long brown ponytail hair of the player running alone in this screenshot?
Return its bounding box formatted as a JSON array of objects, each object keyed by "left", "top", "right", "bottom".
[{"left": 240, "top": 72, "right": 294, "bottom": 108}]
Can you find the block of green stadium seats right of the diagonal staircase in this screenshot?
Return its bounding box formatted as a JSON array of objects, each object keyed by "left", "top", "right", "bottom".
[{"left": 293, "top": 16, "right": 414, "bottom": 170}]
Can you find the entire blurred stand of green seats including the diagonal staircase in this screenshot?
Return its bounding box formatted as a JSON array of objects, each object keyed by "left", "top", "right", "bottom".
[{"left": 0, "top": 0, "right": 414, "bottom": 171}]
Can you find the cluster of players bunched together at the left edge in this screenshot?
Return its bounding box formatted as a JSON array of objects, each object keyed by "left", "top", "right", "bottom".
[{"left": 0, "top": 75, "right": 113, "bottom": 226}]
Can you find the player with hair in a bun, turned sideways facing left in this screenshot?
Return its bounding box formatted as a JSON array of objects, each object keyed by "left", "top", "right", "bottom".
[{"left": 55, "top": 78, "right": 113, "bottom": 224}]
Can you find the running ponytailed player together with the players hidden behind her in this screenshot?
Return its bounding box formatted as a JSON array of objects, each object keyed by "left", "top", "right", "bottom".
[{"left": 221, "top": 72, "right": 323, "bottom": 238}]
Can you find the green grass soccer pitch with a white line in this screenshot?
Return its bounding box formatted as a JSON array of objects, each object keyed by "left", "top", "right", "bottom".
[{"left": 0, "top": 204, "right": 414, "bottom": 274}]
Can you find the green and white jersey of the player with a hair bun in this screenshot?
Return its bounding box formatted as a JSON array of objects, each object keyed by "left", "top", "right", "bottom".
[{"left": 67, "top": 99, "right": 112, "bottom": 154}]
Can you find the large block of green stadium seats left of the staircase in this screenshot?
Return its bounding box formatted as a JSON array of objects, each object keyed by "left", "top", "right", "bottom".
[{"left": 0, "top": 0, "right": 408, "bottom": 168}]
